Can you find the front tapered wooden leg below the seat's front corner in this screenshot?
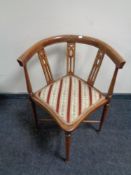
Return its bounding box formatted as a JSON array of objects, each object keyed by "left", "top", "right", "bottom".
[{"left": 65, "top": 132, "right": 71, "bottom": 161}]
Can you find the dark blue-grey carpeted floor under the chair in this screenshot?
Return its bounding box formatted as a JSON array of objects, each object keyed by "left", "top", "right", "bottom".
[{"left": 0, "top": 99, "right": 131, "bottom": 175}]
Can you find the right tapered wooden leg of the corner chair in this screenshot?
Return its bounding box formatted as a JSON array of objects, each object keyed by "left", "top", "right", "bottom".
[{"left": 98, "top": 104, "right": 109, "bottom": 131}]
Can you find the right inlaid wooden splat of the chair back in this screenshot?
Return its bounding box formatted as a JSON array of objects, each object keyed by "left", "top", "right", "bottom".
[{"left": 88, "top": 49, "right": 104, "bottom": 86}]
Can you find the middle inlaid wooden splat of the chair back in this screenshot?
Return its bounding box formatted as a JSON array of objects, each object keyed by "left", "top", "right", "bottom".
[{"left": 67, "top": 43, "right": 75, "bottom": 74}]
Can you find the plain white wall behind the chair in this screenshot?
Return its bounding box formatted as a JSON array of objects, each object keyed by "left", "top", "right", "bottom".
[{"left": 0, "top": 0, "right": 131, "bottom": 93}]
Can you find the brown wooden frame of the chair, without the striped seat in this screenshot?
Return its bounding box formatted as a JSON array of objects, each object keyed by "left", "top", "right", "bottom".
[{"left": 18, "top": 35, "right": 125, "bottom": 160}]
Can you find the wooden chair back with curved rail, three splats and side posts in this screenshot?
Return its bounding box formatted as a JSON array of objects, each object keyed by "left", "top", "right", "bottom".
[{"left": 18, "top": 35, "right": 125, "bottom": 100}]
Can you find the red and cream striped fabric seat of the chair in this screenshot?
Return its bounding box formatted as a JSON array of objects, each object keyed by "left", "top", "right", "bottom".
[{"left": 40, "top": 76, "right": 104, "bottom": 124}]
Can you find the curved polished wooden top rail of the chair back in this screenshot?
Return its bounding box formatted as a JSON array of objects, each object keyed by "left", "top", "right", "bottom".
[{"left": 18, "top": 35, "right": 125, "bottom": 68}]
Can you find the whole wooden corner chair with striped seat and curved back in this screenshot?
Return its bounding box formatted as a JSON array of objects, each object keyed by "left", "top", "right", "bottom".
[{"left": 18, "top": 35, "right": 125, "bottom": 161}]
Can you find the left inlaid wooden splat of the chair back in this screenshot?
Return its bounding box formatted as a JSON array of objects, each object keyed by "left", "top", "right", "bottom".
[{"left": 38, "top": 48, "right": 53, "bottom": 84}]
